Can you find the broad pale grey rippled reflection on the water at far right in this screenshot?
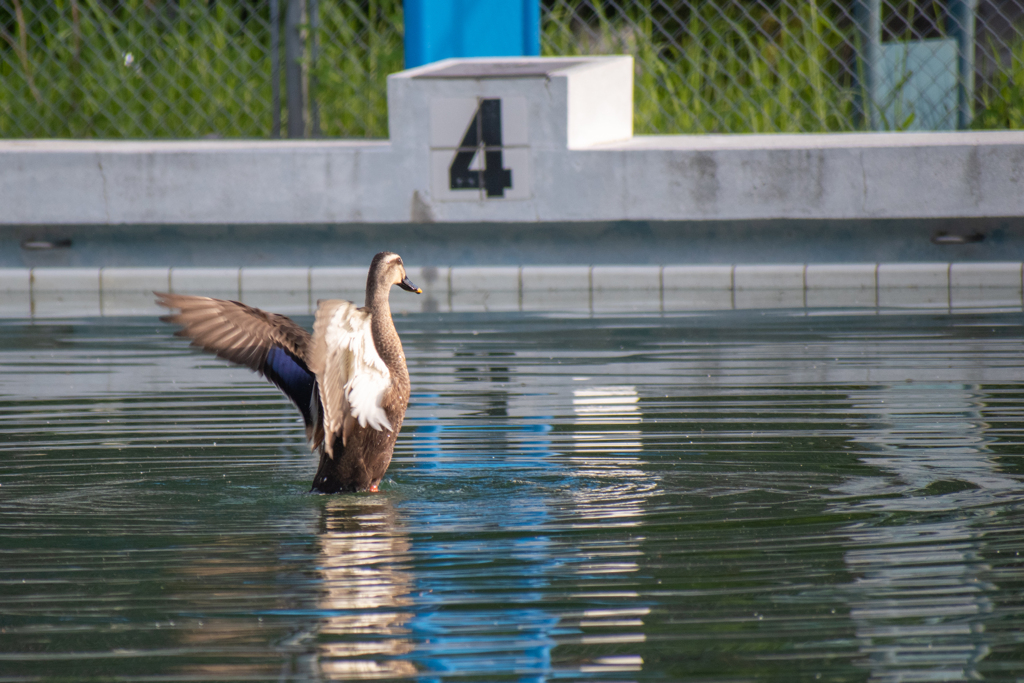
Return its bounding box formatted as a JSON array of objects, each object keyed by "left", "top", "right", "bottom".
[{"left": 841, "top": 383, "right": 1021, "bottom": 681}]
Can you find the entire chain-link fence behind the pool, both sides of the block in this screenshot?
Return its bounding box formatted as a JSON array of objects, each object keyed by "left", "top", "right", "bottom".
[{"left": 0, "top": 0, "right": 1024, "bottom": 138}]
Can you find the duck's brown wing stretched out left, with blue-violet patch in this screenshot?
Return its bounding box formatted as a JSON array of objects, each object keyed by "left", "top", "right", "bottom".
[{"left": 156, "top": 292, "right": 319, "bottom": 440}]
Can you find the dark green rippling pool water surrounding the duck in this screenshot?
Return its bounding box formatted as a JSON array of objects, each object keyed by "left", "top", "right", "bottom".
[{"left": 0, "top": 310, "right": 1024, "bottom": 681}]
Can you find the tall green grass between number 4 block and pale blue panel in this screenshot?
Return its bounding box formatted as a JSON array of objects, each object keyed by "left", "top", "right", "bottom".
[{"left": 542, "top": 0, "right": 856, "bottom": 133}]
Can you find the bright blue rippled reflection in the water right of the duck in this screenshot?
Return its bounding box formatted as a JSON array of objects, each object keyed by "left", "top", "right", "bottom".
[{"left": 408, "top": 394, "right": 563, "bottom": 681}]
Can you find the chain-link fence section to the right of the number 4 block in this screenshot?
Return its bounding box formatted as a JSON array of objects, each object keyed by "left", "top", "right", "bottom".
[{"left": 542, "top": 0, "right": 1024, "bottom": 133}]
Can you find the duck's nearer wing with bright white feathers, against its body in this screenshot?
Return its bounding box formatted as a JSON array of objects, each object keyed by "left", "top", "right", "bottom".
[{"left": 309, "top": 300, "right": 391, "bottom": 458}]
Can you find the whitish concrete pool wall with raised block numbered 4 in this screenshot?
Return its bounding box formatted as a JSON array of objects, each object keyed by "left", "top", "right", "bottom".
[{"left": 0, "top": 57, "right": 1024, "bottom": 311}]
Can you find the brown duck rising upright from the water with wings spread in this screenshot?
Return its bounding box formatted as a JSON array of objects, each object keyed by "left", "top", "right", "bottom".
[{"left": 154, "top": 252, "right": 423, "bottom": 494}]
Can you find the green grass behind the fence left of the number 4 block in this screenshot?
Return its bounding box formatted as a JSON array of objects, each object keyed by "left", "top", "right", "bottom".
[{"left": 0, "top": 0, "right": 402, "bottom": 138}]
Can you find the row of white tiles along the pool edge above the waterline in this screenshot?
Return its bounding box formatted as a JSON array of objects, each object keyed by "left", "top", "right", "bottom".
[{"left": 0, "top": 261, "right": 1024, "bottom": 318}]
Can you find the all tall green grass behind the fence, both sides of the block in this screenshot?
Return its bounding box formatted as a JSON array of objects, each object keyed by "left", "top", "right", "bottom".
[{"left": 0, "top": 0, "right": 1024, "bottom": 138}]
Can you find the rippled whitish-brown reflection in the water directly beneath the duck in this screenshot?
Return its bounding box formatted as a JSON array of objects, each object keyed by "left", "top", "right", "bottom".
[{"left": 316, "top": 497, "right": 417, "bottom": 680}]
